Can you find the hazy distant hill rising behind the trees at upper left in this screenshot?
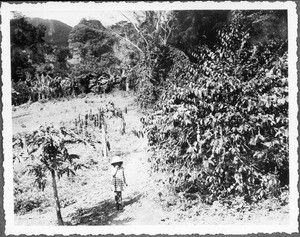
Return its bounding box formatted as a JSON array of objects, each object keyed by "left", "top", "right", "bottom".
[{"left": 28, "top": 18, "right": 72, "bottom": 46}]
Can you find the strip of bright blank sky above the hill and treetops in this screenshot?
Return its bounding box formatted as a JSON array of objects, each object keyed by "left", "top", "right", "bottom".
[{"left": 21, "top": 10, "right": 138, "bottom": 27}]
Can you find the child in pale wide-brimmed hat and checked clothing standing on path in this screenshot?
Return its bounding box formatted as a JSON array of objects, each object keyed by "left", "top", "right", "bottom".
[{"left": 111, "top": 156, "right": 127, "bottom": 210}]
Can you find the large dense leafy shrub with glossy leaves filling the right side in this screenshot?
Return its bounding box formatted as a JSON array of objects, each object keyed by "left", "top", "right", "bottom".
[{"left": 145, "top": 13, "right": 289, "bottom": 203}]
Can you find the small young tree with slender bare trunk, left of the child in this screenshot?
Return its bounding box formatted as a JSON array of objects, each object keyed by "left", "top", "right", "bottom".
[{"left": 15, "top": 125, "right": 85, "bottom": 225}]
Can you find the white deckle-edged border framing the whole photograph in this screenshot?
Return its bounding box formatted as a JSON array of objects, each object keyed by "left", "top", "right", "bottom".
[{"left": 1, "top": 1, "right": 299, "bottom": 235}]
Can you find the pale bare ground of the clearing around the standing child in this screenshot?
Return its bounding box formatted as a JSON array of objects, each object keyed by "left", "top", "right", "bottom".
[{"left": 13, "top": 90, "right": 289, "bottom": 225}]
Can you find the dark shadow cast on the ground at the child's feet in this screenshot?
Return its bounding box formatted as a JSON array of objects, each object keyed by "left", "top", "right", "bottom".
[{"left": 65, "top": 194, "right": 142, "bottom": 225}]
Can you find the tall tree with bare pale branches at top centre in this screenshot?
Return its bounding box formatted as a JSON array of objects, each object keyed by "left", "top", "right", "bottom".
[{"left": 111, "top": 11, "right": 173, "bottom": 93}]
